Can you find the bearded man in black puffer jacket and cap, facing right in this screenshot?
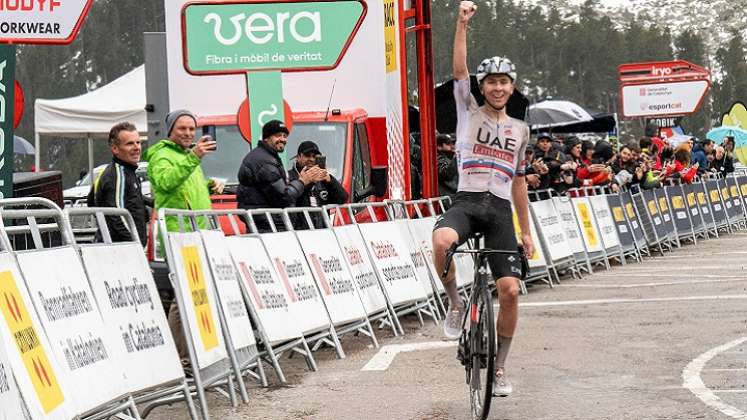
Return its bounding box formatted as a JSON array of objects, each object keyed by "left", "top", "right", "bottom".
[{"left": 236, "top": 120, "right": 326, "bottom": 232}]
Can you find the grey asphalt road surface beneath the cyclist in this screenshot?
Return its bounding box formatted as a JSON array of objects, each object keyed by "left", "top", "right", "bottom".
[{"left": 149, "top": 233, "right": 747, "bottom": 420}]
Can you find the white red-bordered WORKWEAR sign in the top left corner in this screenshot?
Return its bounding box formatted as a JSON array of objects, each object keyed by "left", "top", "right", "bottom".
[{"left": 0, "top": 0, "right": 93, "bottom": 44}]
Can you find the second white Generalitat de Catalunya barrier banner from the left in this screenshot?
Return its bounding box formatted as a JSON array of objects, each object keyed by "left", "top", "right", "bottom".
[{"left": 260, "top": 232, "right": 330, "bottom": 334}]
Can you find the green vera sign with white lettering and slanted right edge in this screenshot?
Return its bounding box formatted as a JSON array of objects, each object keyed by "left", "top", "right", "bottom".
[{"left": 182, "top": 0, "right": 366, "bottom": 74}]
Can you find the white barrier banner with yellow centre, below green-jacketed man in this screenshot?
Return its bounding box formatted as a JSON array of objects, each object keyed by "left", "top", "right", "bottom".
[{"left": 167, "top": 232, "right": 228, "bottom": 369}]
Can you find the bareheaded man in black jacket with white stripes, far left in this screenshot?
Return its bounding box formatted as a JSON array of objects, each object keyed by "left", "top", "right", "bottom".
[{"left": 87, "top": 122, "right": 148, "bottom": 246}]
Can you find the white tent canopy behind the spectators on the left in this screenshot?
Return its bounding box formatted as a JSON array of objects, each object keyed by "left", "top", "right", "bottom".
[{"left": 34, "top": 66, "right": 148, "bottom": 172}]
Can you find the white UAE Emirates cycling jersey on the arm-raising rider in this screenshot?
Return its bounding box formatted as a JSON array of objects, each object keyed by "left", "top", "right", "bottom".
[{"left": 454, "top": 79, "right": 529, "bottom": 201}]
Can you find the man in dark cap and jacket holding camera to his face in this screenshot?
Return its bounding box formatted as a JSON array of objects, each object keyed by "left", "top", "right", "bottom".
[{"left": 288, "top": 141, "right": 348, "bottom": 229}]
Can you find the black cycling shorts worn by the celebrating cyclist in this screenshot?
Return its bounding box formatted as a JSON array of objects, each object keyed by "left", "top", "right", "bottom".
[{"left": 433, "top": 191, "right": 521, "bottom": 278}]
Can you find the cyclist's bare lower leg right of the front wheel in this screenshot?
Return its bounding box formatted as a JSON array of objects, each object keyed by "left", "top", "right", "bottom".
[{"left": 495, "top": 277, "right": 519, "bottom": 372}]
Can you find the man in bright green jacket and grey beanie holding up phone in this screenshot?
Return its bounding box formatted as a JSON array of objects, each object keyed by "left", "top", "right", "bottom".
[{"left": 144, "top": 110, "right": 223, "bottom": 365}]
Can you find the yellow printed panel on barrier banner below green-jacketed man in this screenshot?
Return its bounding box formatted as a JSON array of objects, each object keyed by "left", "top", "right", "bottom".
[{"left": 182, "top": 245, "right": 218, "bottom": 351}]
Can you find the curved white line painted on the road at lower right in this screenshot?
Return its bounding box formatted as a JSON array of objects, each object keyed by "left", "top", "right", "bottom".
[{"left": 682, "top": 337, "right": 747, "bottom": 419}]
